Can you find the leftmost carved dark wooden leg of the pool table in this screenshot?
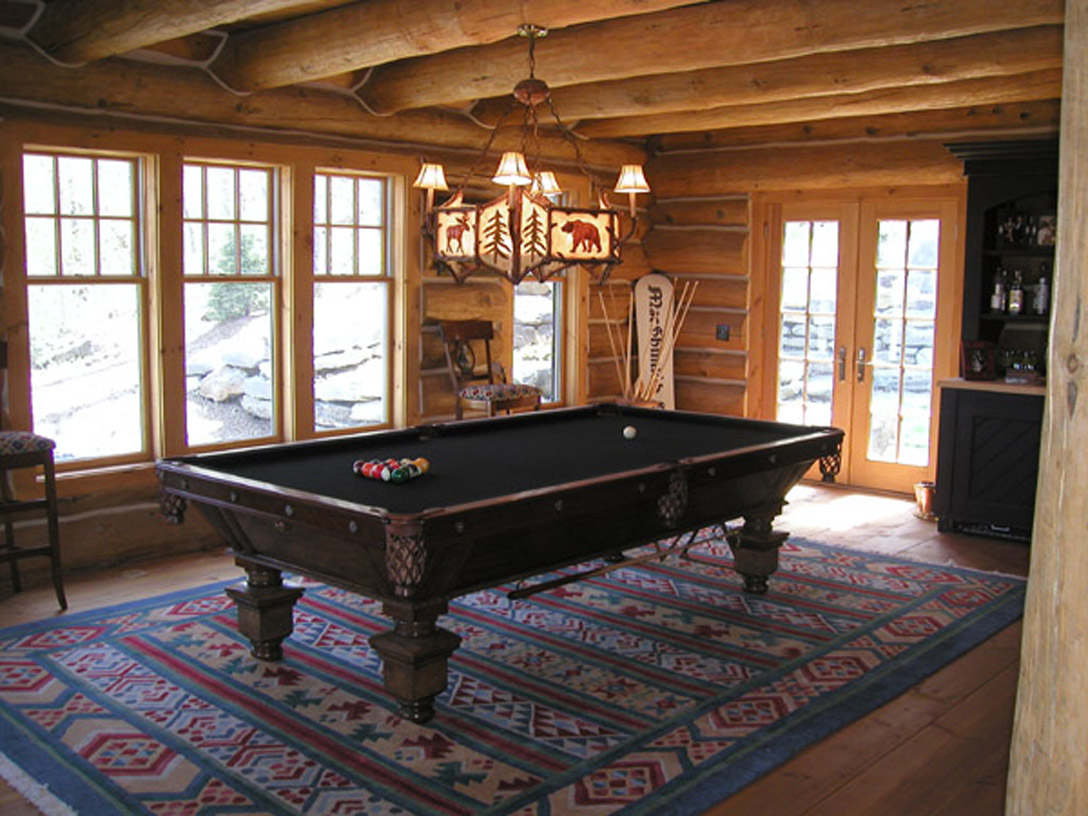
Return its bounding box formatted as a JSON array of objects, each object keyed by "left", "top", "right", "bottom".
[{"left": 226, "top": 558, "right": 302, "bottom": 660}]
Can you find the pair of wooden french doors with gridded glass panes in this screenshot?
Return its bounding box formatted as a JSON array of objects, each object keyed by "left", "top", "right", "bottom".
[{"left": 764, "top": 198, "right": 960, "bottom": 492}]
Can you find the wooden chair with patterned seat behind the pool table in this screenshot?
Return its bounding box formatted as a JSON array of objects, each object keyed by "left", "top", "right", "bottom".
[{"left": 440, "top": 320, "right": 541, "bottom": 419}]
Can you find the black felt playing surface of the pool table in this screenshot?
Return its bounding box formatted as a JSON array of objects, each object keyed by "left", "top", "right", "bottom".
[{"left": 183, "top": 409, "right": 817, "bottom": 514}]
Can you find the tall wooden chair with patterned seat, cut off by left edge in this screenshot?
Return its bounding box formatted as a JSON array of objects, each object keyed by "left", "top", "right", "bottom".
[{"left": 0, "top": 343, "right": 67, "bottom": 609}]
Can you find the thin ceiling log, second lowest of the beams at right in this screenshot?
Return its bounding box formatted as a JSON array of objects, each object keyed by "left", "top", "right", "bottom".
[{"left": 574, "top": 69, "right": 1062, "bottom": 138}]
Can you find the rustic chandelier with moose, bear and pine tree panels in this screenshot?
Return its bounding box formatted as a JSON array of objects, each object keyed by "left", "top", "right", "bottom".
[{"left": 412, "top": 24, "right": 650, "bottom": 284}]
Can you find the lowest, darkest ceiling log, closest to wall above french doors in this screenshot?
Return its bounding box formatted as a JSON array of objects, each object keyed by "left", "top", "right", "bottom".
[{"left": 651, "top": 99, "right": 1062, "bottom": 153}]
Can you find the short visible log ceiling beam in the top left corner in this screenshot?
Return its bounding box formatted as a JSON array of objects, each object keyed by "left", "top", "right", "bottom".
[{"left": 27, "top": 0, "right": 302, "bottom": 64}]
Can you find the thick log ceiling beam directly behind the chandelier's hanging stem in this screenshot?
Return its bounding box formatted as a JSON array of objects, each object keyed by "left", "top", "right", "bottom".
[{"left": 360, "top": 0, "right": 1064, "bottom": 113}]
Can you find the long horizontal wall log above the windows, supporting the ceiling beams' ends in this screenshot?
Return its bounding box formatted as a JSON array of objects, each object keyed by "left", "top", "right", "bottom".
[{"left": 0, "top": 40, "right": 645, "bottom": 169}]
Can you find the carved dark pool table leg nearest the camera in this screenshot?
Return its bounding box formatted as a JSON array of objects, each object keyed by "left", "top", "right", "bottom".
[{"left": 370, "top": 602, "right": 461, "bottom": 722}]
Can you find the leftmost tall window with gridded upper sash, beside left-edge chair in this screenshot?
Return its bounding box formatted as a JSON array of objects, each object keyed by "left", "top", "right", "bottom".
[{"left": 23, "top": 152, "right": 147, "bottom": 461}]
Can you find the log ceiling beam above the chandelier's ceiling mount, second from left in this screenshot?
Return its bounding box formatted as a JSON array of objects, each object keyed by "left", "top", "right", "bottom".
[{"left": 214, "top": 0, "right": 691, "bottom": 91}]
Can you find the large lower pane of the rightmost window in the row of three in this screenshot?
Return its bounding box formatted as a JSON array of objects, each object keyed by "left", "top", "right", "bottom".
[{"left": 313, "top": 281, "right": 390, "bottom": 430}]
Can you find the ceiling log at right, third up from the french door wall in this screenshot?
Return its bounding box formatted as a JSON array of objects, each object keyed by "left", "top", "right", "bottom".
[{"left": 472, "top": 25, "right": 1063, "bottom": 125}]
